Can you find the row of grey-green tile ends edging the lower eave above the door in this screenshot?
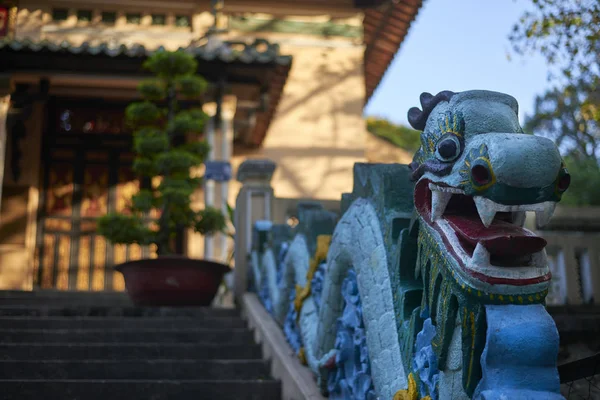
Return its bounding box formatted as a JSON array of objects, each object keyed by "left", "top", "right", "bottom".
[{"left": 0, "top": 38, "right": 291, "bottom": 65}]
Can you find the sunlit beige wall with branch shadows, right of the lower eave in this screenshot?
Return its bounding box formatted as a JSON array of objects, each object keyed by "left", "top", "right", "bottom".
[{"left": 233, "top": 35, "right": 367, "bottom": 199}]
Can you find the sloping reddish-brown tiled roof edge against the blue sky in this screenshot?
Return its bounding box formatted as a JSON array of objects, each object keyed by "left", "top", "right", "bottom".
[{"left": 363, "top": 0, "right": 423, "bottom": 104}]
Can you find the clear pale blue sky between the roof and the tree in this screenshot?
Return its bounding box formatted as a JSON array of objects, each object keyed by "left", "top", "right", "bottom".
[{"left": 365, "top": 0, "right": 550, "bottom": 124}]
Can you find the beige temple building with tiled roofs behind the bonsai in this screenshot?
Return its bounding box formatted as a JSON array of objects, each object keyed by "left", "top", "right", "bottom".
[{"left": 0, "top": 0, "right": 421, "bottom": 290}]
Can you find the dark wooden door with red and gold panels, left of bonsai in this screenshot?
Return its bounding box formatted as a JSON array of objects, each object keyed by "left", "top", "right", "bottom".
[{"left": 34, "top": 99, "right": 153, "bottom": 291}]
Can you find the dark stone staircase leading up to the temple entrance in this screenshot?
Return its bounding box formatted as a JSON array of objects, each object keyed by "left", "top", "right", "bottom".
[{"left": 0, "top": 291, "right": 281, "bottom": 400}]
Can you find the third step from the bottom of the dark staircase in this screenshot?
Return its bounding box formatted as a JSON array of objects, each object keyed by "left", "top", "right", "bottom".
[{"left": 0, "top": 342, "right": 261, "bottom": 360}]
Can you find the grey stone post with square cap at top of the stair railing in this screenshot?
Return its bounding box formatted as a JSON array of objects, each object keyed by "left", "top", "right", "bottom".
[{"left": 234, "top": 160, "right": 275, "bottom": 301}]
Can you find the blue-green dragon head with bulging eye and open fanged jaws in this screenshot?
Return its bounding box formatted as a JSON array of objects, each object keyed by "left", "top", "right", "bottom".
[{"left": 408, "top": 90, "right": 570, "bottom": 300}]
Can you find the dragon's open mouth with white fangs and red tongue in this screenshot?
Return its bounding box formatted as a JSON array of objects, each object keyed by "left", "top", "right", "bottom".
[{"left": 415, "top": 179, "right": 556, "bottom": 286}]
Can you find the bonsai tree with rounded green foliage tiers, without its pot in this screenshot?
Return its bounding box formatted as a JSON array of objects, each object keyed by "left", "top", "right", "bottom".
[{"left": 98, "top": 51, "right": 225, "bottom": 255}]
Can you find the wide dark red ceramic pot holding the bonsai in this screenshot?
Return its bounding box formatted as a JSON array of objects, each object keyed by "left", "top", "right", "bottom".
[{"left": 115, "top": 256, "right": 230, "bottom": 306}]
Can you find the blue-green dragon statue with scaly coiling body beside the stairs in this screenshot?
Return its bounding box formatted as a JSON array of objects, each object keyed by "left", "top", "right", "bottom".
[{"left": 251, "top": 90, "right": 570, "bottom": 400}]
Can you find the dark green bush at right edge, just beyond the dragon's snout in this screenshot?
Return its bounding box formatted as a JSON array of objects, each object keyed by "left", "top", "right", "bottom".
[{"left": 561, "top": 156, "right": 600, "bottom": 207}]
